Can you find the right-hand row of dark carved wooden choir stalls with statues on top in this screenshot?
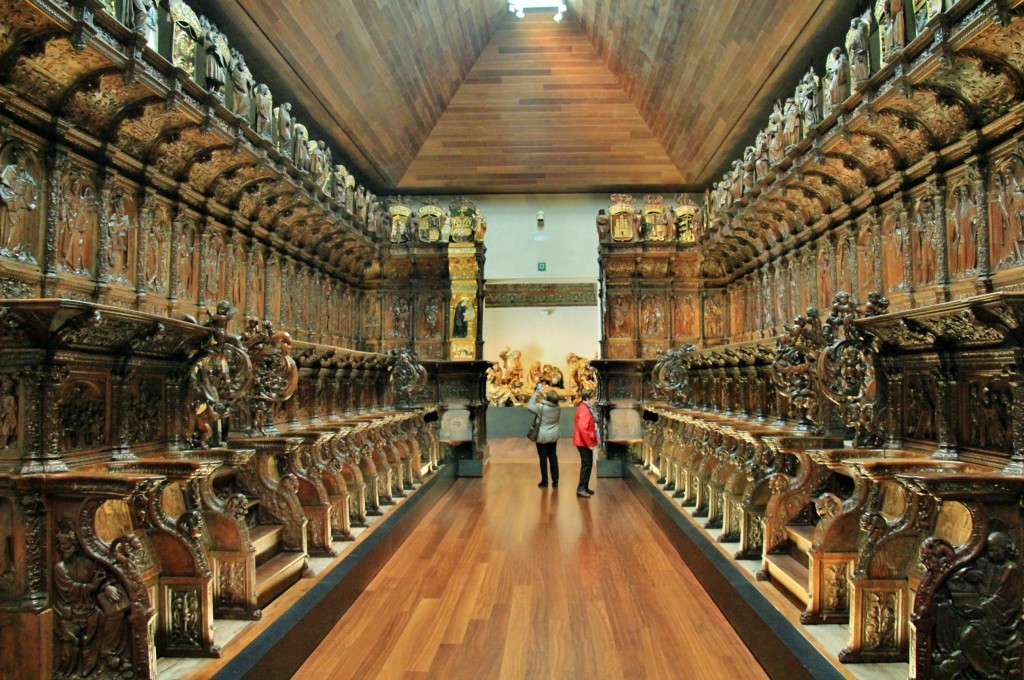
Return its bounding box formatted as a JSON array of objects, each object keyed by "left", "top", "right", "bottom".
[{"left": 595, "top": 0, "right": 1024, "bottom": 678}]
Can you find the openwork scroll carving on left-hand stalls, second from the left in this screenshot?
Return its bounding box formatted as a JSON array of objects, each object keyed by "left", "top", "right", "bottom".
[{"left": 242, "top": 316, "right": 299, "bottom": 435}]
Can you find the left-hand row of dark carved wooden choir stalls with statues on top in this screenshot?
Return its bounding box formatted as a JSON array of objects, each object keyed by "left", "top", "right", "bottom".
[{"left": 0, "top": 0, "right": 485, "bottom": 678}]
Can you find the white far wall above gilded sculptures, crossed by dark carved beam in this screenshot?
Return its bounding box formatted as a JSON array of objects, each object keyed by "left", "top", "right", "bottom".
[{"left": 473, "top": 194, "right": 609, "bottom": 374}]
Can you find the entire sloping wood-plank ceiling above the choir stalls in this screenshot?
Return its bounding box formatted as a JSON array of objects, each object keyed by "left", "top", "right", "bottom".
[{"left": 203, "top": 0, "right": 855, "bottom": 194}]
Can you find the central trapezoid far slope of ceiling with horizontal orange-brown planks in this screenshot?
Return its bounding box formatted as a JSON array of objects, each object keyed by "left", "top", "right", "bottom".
[{"left": 398, "top": 12, "right": 682, "bottom": 194}]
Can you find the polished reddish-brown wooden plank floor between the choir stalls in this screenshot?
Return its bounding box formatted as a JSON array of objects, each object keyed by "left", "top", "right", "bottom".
[{"left": 294, "top": 439, "right": 767, "bottom": 680}]
